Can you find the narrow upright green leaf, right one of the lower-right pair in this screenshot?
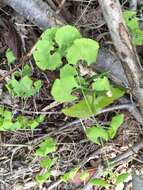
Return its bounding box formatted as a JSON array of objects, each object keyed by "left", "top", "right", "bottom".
[{"left": 108, "top": 114, "right": 124, "bottom": 139}]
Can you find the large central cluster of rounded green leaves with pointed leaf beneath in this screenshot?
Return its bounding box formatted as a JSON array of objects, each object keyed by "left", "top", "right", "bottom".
[{"left": 33, "top": 25, "right": 124, "bottom": 118}]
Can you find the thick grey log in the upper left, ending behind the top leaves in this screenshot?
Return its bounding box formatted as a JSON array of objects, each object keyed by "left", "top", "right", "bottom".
[{"left": 3, "top": 0, "right": 65, "bottom": 30}]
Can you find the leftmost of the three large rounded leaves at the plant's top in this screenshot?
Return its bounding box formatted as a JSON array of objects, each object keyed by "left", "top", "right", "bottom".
[{"left": 33, "top": 28, "right": 62, "bottom": 70}]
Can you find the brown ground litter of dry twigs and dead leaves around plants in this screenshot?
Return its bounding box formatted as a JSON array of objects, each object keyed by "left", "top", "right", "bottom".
[{"left": 0, "top": 0, "right": 143, "bottom": 190}]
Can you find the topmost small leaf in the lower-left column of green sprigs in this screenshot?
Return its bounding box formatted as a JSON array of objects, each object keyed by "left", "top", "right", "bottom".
[{"left": 36, "top": 137, "right": 56, "bottom": 156}]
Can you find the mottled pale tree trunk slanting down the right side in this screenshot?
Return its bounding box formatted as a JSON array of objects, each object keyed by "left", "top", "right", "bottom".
[{"left": 99, "top": 0, "right": 143, "bottom": 116}]
